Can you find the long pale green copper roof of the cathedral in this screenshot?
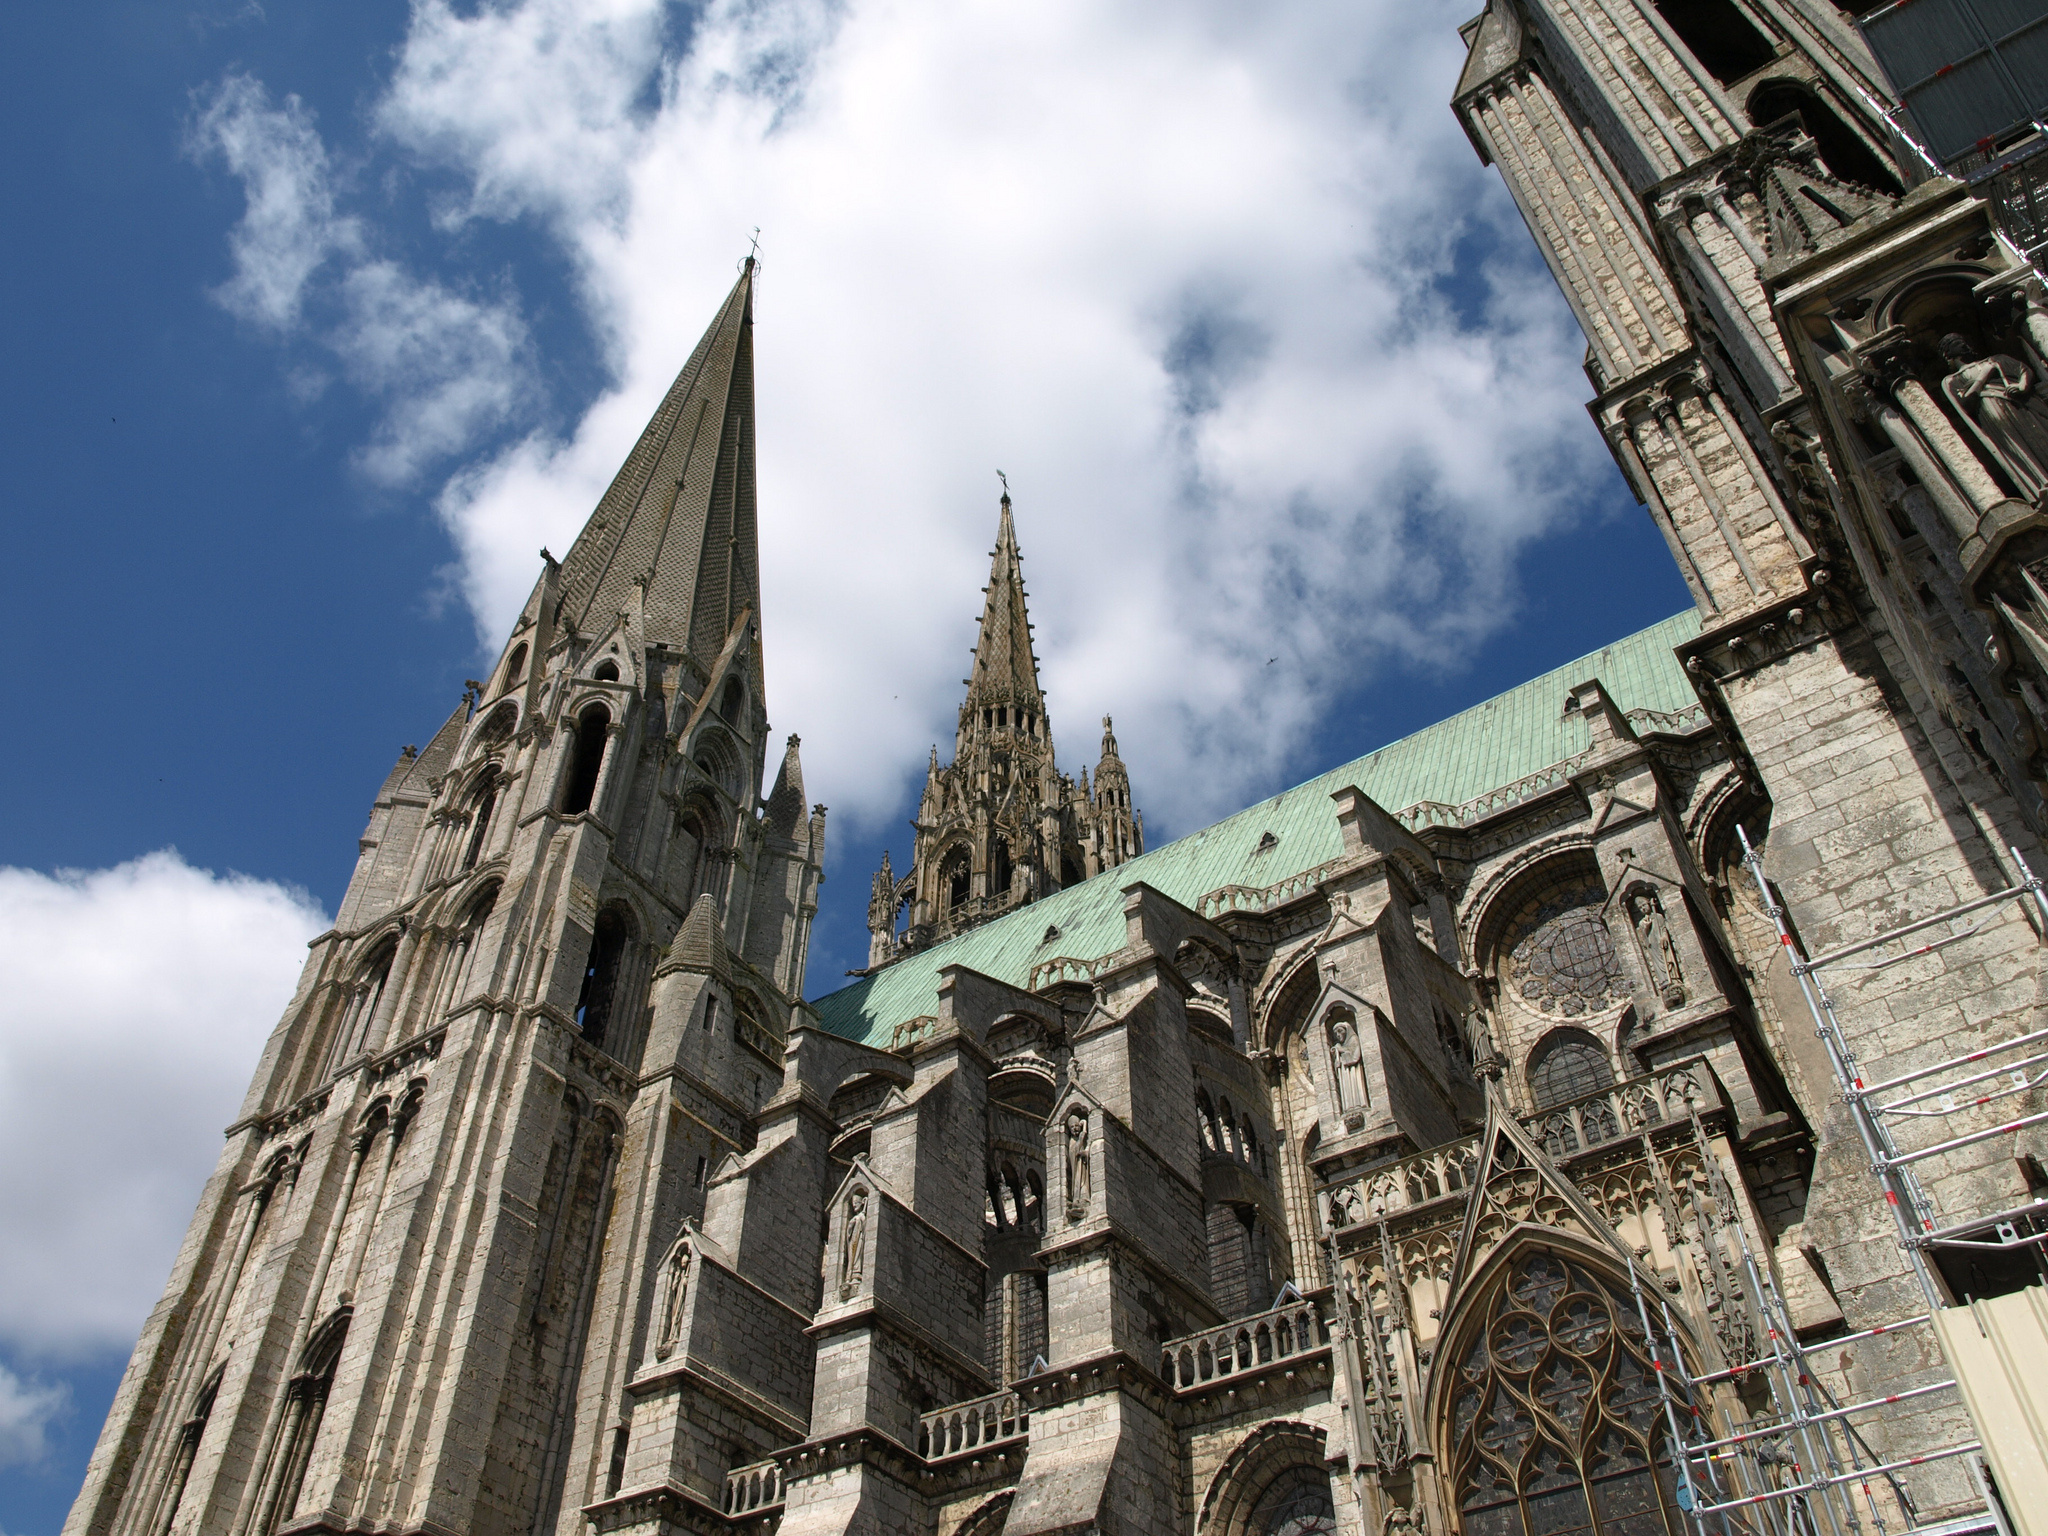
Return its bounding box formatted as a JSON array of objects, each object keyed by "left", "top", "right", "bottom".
[{"left": 813, "top": 610, "right": 1704, "bottom": 1047}]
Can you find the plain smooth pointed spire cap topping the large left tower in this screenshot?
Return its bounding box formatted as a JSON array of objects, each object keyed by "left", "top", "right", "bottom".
[{"left": 559, "top": 256, "right": 760, "bottom": 670}]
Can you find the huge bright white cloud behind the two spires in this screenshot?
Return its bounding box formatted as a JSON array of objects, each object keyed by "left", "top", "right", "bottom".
[{"left": 207, "top": 0, "right": 1612, "bottom": 843}]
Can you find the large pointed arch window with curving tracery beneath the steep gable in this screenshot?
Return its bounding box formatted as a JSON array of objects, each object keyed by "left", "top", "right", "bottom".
[{"left": 1440, "top": 1249, "right": 1686, "bottom": 1536}]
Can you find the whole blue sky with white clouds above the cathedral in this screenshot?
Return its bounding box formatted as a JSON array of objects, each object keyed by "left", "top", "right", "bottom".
[{"left": 0, "top": 0, "right": 1686, "bottom": 1536}]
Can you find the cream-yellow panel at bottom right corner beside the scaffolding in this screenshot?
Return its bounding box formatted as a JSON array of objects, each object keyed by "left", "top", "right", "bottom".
[{"left": 1933, "top": 1286, "right": 2048, "bottom": 1536}]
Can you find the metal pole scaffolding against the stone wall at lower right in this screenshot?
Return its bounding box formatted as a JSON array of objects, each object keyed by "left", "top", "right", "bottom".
[{"left": 1636, "top": 834, "right": 2048, "bottom": 1536}]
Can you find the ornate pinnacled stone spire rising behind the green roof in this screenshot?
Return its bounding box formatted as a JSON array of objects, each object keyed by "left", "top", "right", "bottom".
[{"left": 868, "top": 499, "right": 1145, "bottom": 969}]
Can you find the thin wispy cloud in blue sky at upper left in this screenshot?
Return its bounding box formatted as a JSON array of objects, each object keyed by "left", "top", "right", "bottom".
[{"left": 188, "top": 74, "right": 537, "bottom": 485}]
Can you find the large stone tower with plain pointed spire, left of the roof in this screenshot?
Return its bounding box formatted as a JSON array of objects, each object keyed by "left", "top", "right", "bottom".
[{"left": 66, "top": 260, "right": 825, "bottom": 1536}]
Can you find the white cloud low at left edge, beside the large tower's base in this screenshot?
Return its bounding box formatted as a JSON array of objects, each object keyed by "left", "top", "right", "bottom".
[{"left": 0, "top": 850, "right": 326, "bottom": 1359}]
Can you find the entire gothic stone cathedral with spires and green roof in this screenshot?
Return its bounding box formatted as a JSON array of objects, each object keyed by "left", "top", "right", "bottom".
[{"left": 68, "top": 0, "right": 2048, "bottom": 1536}]
